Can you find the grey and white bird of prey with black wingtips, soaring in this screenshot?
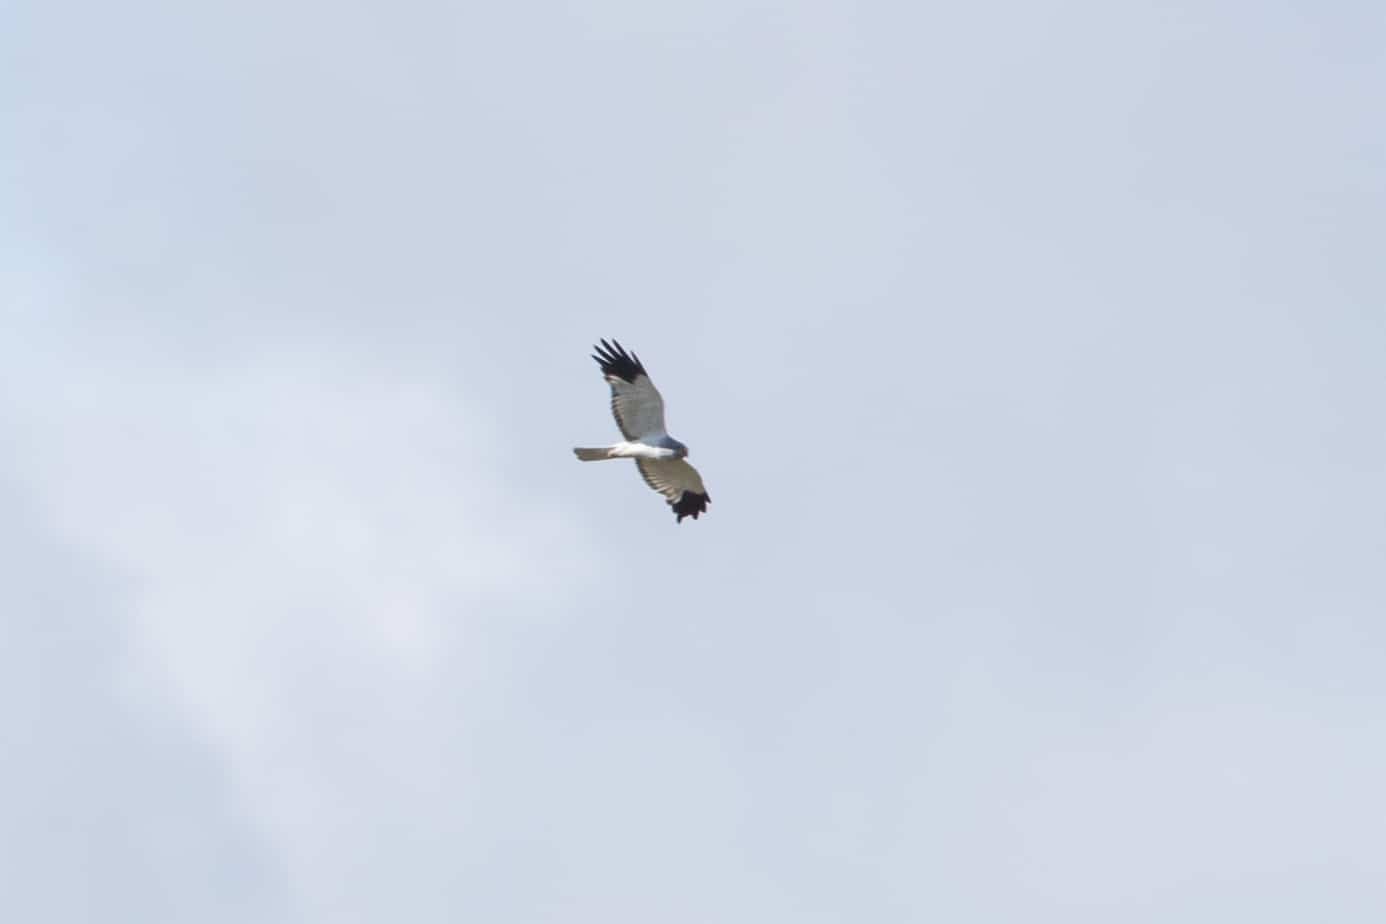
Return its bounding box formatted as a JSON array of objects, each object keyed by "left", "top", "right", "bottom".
[{"left": 572, "top": 341, "right": 712, "bottom": 522}]
